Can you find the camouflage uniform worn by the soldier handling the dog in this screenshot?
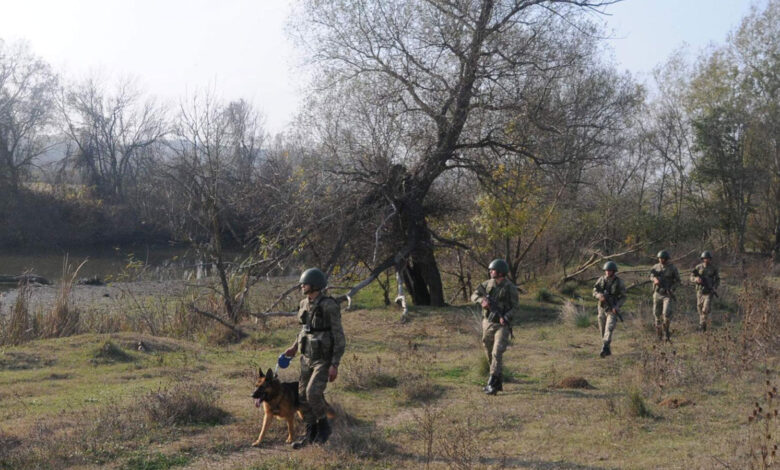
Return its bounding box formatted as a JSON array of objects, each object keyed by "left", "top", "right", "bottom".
[{"left": 295, "top": 293, "right": 346, "bottom": 423}]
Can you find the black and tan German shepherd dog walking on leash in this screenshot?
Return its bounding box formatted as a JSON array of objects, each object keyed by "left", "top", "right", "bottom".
[{"left": 252, "top": 369, "right": 303, "bottom": 447}]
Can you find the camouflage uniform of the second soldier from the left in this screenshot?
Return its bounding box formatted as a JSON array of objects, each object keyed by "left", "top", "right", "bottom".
[{"left": 471, "top": 278, "right": 518, "bottom": 377}]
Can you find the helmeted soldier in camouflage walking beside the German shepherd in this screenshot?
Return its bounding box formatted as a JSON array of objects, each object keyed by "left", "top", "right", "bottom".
[{"left": 285, "top": 268, "right": 346, "bottom": 449}]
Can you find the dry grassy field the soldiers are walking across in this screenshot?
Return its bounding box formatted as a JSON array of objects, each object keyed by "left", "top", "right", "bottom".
[{"left": 0, "top": 268, "right": 780, "bottom": 470}]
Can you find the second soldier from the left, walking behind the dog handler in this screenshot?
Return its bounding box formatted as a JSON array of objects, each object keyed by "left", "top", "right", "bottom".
[{"left": 471, "top": 259, "right": 518, "bottom": 395}]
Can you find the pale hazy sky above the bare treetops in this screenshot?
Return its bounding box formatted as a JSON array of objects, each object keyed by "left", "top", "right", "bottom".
[{"left": 0, "top": 0, "right": 765, "bottom": 132}]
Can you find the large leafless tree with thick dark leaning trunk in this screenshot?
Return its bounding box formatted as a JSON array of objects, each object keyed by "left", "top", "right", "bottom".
[{"left": 296, "top": 0, "right": 623, "bottom": 305}]
